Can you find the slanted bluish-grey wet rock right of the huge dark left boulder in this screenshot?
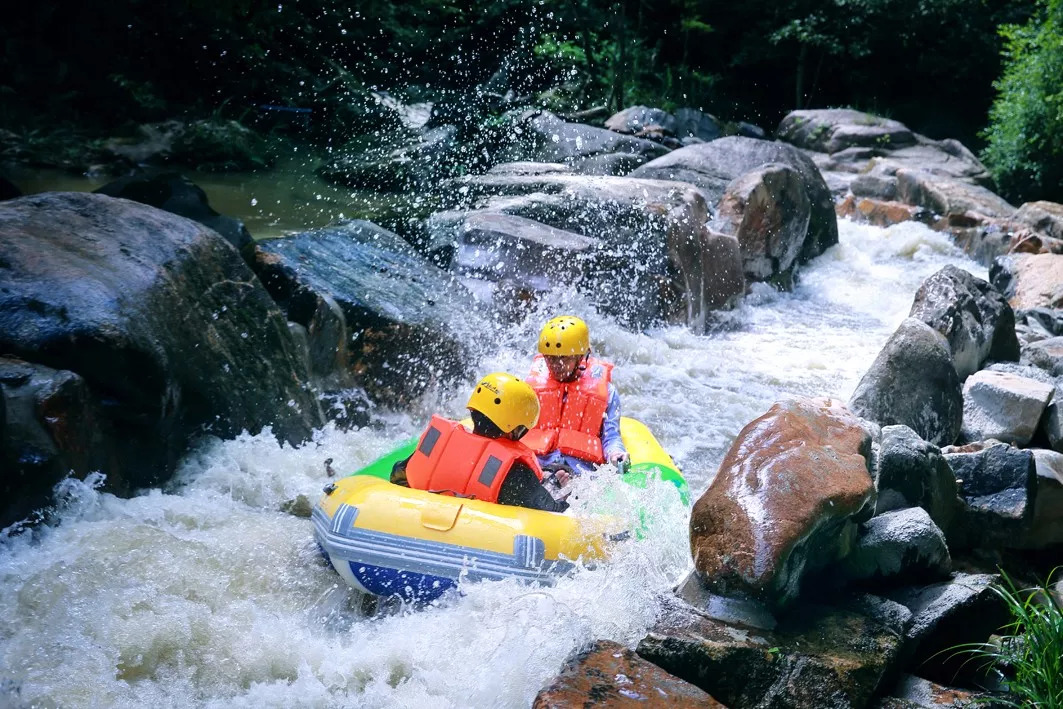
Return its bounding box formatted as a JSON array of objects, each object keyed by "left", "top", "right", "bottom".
[{"left": 254, "top": 220, "right": 475, "bottom": 404}]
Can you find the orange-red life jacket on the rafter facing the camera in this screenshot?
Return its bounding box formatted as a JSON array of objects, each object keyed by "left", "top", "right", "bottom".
[{"left": 521, "top": 354, "right": 612, "bottom": 463}]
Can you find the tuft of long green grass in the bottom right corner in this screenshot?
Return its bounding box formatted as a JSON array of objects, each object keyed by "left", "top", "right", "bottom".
[{"left": 957, "top": 574, "right": 1063, "bottom": 709}]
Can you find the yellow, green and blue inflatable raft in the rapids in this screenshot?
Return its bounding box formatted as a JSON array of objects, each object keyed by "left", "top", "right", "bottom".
[{"left": 313, "top": 418, "right": 687, "bottom": 602}]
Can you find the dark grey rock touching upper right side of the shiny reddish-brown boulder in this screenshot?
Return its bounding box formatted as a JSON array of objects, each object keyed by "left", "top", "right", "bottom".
[{"left": 876, "top": 426, "right": 958, "bottom": 533}]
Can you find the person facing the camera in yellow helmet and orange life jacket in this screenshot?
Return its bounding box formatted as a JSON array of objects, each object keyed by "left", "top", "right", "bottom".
[{"left": 524, "top": 315, "right": 628, "bottom": 484}]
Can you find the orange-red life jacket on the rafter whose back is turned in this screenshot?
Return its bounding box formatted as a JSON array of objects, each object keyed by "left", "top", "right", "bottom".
[{"left": 406, "top": 416, "right": 542, "bottom": 502}]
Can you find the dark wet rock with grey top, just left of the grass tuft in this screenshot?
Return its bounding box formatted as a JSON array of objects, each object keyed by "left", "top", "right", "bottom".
[{"left": 885, "top": 574, "right": 1008, "bottom": 682}]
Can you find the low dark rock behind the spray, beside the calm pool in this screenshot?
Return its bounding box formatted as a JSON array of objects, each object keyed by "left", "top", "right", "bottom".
[{"left": 317, "top": 125, "right": 458, "bottom": 191}]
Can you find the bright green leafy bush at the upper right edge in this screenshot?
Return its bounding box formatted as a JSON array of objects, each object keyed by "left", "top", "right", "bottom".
[{"left": 982, "top": 0, "right": 1063, "bottom": 201}]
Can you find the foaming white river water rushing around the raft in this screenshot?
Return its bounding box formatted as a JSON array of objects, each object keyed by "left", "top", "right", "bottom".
[{"left": 0, "top": 209, "right": 985, "bottom": 707}]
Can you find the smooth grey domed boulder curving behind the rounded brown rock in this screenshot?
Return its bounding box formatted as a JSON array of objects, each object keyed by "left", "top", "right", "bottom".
[{"left": 631, "top": 136, "right": 838, "bottom": 261}]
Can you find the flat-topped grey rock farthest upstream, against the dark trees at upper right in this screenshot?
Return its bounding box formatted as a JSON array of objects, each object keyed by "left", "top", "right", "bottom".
[{"left": 775, "top": 108, "right": 915, "bottom": 153}]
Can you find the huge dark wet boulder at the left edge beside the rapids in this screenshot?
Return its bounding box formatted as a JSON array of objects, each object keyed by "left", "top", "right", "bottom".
[{"left": 0, "top": 192, "right": 323, "bottom": 516}]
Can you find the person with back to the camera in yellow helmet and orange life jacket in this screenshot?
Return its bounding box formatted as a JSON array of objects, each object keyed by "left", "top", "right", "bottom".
[{"left": 391, "top": 372, "right": 569, "bottom": 512}]
